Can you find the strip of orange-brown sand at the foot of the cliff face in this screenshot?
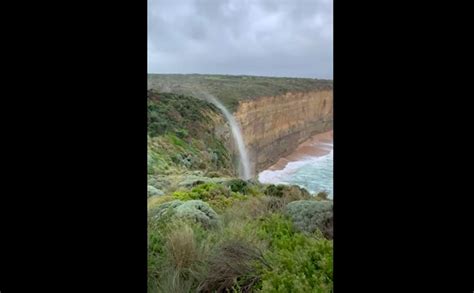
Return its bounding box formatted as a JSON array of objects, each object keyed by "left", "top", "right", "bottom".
[{"left": 268, "top": 130, "right": 333, "bottom": 171}]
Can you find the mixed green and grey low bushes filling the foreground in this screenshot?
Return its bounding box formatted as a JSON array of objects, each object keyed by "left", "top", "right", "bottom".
[{"left": 148, "top": 183, "right": 333, "bottom": 293}]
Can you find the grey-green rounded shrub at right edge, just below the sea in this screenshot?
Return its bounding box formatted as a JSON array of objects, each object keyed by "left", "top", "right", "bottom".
[{"left": 285, "top": 200, "right": 333, "bottom": 238}]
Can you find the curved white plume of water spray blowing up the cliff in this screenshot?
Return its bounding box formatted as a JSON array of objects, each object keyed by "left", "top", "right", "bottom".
[{"left": 205, "top": 94, "right": 251, "bottom": 180}]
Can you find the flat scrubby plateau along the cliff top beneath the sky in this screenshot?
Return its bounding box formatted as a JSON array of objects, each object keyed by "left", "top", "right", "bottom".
[{"left": 148, "top": 74, "right": 332, "bottom": 111}]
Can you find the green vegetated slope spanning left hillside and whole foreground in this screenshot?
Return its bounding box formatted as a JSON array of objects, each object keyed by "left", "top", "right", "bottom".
[{"left": 148, "top": 92, "right": 332, "bottom": 292}]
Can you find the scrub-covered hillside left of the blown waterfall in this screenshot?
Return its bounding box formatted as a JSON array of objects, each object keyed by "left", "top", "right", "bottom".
[{"left": 148, "top": 91, "right": 235, "bottom": 196}]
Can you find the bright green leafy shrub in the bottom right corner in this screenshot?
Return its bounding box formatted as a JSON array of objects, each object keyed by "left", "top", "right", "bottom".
[{"left": 252, "top": 214, "right": 333, "bottom": 292}]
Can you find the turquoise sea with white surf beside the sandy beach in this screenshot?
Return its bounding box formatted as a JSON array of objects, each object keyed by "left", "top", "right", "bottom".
[{"left": 258, "top": 144, "right": 333, "bottom": 199}]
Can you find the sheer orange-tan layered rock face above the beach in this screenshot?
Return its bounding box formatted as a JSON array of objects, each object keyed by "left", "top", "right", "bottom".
[{"left": 234, "top": 90, "right": 333, "bottom": 175}]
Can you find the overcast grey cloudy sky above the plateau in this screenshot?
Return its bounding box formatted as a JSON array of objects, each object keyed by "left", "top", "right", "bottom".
[{"left": 148, "top": 0, "right": 333, "bottom": 79}]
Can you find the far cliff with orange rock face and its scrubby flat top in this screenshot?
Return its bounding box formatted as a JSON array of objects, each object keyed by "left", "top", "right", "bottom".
[{"left": 148, "top": 74, "right": 333, "bottom": 175}]
